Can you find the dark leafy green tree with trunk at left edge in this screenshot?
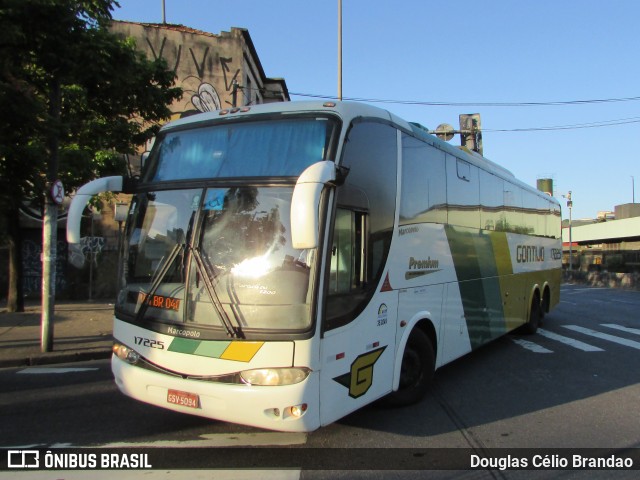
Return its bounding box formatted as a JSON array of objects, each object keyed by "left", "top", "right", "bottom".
[{"left": 0, "top": 0, "right": 182, "bottom": 311}]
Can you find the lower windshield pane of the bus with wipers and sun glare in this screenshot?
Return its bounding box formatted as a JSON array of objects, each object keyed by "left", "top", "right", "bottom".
[{"left": 117, "top": 186, "right": 315, "bottom": 338}]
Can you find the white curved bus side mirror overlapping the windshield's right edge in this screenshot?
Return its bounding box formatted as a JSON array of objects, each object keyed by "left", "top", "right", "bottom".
[{"left": 291, "top": 160, "right": 336, "bottom": 249}]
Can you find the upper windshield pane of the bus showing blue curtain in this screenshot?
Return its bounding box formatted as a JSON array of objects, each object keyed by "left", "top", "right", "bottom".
[{"left": 143, "top": 117, "right": 336, "bottom": 182}]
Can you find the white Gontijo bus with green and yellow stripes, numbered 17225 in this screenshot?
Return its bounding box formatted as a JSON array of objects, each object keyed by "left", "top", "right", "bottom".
[{"left": 68, "top": 102, "right": 562, "bottom": 431}]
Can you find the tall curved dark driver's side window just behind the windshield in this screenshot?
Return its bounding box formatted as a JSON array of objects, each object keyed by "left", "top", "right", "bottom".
[{"left": 324, "top": 121, "right": 398, "bottom": 331}]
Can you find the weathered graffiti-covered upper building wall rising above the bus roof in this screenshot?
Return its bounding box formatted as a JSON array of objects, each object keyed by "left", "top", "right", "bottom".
[{"left": 111, "top": 21, "right": 290, "bottom": 118}]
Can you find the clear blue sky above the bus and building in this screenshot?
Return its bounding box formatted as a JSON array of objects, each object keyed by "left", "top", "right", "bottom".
[{"left": 113, "top": 0, "right": 640, "bottom": 219}]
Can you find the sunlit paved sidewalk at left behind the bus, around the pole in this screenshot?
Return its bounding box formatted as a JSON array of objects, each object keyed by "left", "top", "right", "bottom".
[{"left": 0, "top": 301, "right": 113, "bottom": 368}]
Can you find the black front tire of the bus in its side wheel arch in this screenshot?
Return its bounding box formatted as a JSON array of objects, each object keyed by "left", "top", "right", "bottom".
[{"left": 382, "top": 328, "right": 436, "bottom": 407}]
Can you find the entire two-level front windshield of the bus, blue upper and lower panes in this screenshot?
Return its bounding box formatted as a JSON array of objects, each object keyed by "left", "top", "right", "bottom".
[{"left": 116, "top": 116, "right": 338, "bottom": 338}]
